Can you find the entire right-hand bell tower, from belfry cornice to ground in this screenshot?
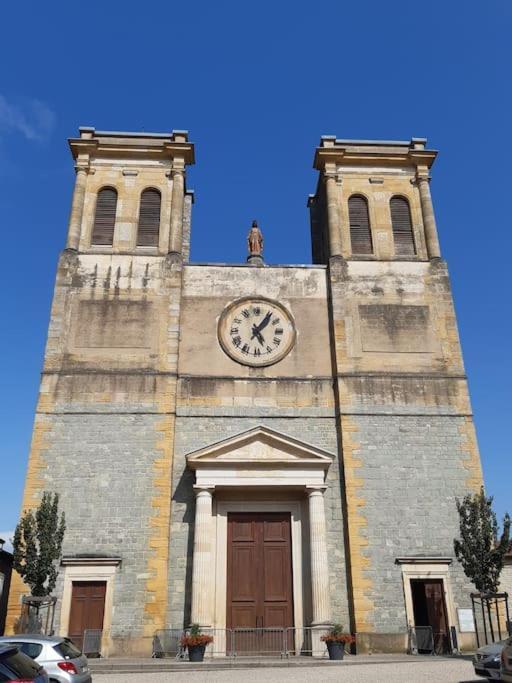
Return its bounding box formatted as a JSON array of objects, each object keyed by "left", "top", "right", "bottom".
[{"left": 308, "top": 136, "right": 482, "bottom": 649}]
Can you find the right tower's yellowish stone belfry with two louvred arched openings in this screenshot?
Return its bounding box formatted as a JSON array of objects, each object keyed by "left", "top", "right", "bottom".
[{"left": 308, "top": 136, "right": 441, "bottom": 263}]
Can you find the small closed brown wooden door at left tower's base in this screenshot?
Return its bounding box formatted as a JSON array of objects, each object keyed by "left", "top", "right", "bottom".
[{"left": 68, "top": 581, "right": 107, "bottom": 649}]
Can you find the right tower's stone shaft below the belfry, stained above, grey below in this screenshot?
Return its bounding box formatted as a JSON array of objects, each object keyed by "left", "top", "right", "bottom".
[{"left": 330, "top": 259, "right": 482, "bottom": 633}]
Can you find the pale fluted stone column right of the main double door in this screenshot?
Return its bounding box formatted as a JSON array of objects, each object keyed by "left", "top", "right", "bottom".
[{"left": 307, "top": 487, "right": 331, "bottom": 626}]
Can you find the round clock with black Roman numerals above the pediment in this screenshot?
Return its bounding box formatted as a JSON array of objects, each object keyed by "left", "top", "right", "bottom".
[{"left": 218, "top": 297, "right": 295, "bottom": 367}]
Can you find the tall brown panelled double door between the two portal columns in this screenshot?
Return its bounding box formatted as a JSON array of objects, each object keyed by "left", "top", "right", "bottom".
[{"left": 226, "top": 512, "right": 293, "bottom": 628}]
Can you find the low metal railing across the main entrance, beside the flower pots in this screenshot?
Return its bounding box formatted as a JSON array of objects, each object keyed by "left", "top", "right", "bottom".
[{"left": 153, "top": 626, "right": 328, "bottom": 659}]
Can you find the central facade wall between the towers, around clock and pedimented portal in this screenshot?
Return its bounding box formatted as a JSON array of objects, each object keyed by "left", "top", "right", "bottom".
[{"left": 169, "top": 265, "right": 349, "bottom": 628}]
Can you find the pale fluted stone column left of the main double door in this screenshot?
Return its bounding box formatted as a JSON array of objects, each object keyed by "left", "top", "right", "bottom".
[{"left": 191, "top": 486, "right": 215, "bottom": 628}]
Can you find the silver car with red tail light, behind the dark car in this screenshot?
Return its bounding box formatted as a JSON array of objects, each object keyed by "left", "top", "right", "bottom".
[{"left": 0, "top": 635, "right": 92, "bottom": 683}]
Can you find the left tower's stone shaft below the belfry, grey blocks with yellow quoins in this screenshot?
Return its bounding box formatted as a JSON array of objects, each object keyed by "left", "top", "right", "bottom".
[{"left": 9, "top": 252, "right": 181, "bottom": 648}]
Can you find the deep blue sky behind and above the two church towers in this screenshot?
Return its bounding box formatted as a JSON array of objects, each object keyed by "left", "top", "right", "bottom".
[{"left": 0, "top": 0, "right": 512, "bottom": 531}]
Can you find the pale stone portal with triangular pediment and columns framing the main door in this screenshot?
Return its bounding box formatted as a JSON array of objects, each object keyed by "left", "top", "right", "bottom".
[{"left": 187, "top": 427, "right": 334, "bottom": 628}]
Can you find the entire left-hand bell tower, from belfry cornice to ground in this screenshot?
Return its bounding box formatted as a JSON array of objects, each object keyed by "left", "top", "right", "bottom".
[{"left": 7, "top": 128, "right": 194, "bottom": 652}]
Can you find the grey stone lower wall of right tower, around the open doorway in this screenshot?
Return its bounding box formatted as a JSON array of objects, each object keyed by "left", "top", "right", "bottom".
[{"left": 344, "top": 408, "right": 480, "bottom": 633}]
